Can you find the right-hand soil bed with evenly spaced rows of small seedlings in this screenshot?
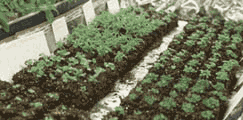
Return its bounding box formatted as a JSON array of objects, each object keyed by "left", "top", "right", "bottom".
[{"left": 103, "top": 5, "right": 243, "bottom": 120}]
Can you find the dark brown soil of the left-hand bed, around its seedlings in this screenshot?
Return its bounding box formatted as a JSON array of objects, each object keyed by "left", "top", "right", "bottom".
[{"left": 0, "top": 3, "right": 178, "bottom": 120}]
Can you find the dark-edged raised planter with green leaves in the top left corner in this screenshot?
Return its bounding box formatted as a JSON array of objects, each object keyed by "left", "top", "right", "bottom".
[{"left": 0, "top": 0, "right": 89, "bottom": 41}]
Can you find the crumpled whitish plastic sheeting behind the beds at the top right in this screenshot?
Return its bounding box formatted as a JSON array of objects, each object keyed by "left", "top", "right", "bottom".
[{"left": 136, "top": 0, "right": 243, "bottom": 21}]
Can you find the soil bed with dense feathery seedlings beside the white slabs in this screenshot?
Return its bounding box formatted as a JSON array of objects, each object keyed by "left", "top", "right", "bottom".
[{"left": 0, "top": 4, "right": 178, "bottom": 119}]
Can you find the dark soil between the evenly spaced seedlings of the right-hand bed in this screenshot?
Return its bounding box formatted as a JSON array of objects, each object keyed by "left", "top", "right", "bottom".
[{"left": 103, "top": 5, "right": 243, "bottom": 120}]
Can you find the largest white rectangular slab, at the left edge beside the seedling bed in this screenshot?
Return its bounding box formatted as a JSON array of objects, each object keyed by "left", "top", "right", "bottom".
[{"left": 0, "top": 31, "right": 50, "bottom": 82}]
